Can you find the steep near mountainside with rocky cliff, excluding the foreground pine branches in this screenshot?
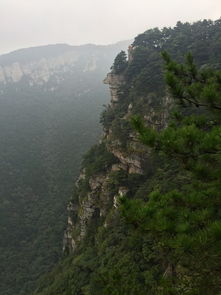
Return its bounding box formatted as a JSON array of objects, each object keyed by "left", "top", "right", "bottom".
[{"left": 35, "top": 20, "right": 221, "bottom": 295}]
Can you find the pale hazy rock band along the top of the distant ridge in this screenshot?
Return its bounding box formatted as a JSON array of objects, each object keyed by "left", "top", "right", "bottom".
[{"left": 0, "top": 41, "right": 131, "bottom": 86}]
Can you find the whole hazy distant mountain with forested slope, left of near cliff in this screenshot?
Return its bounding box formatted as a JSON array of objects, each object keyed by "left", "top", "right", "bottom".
[{"left": 0, "top": 41, "right": 130, "bottom": 295}]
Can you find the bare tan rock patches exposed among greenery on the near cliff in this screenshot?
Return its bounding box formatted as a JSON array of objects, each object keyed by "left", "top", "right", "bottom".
[{"left": 65, "top": 59, "right": 170, "bottom": 251}]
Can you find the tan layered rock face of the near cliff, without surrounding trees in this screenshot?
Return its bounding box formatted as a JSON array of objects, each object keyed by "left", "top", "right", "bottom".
[{"left": 63, "top": 53, "right": 170, "bottom": 252}]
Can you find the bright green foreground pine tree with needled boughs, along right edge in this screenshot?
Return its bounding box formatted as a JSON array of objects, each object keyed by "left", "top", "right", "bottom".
[{"left": 121, "top": 52, "right": 221, "bottom": 295}]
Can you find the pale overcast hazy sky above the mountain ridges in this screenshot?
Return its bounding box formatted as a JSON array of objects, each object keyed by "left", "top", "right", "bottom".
[{"left": 0, "top": 0, "right": 221, "bottom": 54}]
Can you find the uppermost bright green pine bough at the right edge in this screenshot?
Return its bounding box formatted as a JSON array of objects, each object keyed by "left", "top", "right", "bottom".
[{"left": 162, "top": 52, "right": 221, "bottom": 110}]
